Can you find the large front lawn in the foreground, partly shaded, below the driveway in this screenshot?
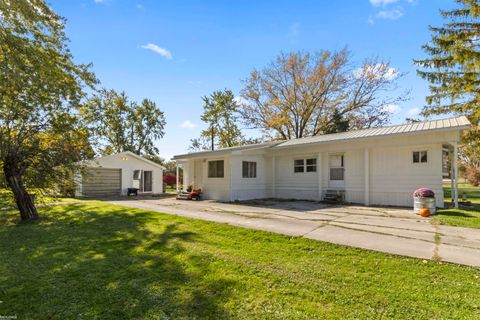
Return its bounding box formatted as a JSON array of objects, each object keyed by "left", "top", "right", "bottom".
[{"left": 0, "top": 201, "right": 480, "bottom": 319}]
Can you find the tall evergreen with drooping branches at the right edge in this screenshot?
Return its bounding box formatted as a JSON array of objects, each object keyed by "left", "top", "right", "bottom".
[{"left": 415, "top": 0, "right": 480, "bottom": 180}]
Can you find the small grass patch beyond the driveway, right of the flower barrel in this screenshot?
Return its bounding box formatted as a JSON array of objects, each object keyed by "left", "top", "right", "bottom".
[{"left": 434, "top": 184, "right": 480, "bottom": 228}]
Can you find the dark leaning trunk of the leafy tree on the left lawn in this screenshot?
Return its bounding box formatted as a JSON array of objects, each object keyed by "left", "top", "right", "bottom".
[{"left": 3, "top": 159, "right": 38, "bottom": 221}]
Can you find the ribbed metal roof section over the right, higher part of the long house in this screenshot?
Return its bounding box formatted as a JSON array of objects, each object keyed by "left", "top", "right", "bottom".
[{"left": 275, "top": 116, "right": 470, "bottom": 148}]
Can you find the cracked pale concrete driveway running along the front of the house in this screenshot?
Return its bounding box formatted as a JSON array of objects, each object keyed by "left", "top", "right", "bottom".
[{"left": 108, "top": 198, "right": 480, "bottom": 266}]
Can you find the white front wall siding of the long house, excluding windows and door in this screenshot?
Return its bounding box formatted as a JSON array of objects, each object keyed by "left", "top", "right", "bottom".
[{"left": 177, "top": 131, "right": 459, "bottom": 206}]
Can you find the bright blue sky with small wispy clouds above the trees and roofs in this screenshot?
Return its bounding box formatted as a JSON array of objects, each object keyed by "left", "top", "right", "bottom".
[{"left": 50, "top": 0, "right": 454, "bottom": 159}]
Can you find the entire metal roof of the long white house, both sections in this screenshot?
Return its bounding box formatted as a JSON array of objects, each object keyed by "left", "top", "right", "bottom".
[{"left": 173, "top": 116, "right": 470, "bottom": 160}]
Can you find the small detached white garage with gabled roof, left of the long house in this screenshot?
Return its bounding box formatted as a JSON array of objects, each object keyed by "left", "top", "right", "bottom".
[{"left": 76, "top": 151, "right": 165, "bottom": 197}]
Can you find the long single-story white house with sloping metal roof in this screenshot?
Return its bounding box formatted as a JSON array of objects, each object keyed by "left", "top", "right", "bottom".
[{"left": 174, "top": 117, "right": 470, "bottom": 207}]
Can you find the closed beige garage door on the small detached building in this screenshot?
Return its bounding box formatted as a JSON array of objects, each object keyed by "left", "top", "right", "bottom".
[{"left": 82, "top": 168, "right": 122, "bottom": 197}]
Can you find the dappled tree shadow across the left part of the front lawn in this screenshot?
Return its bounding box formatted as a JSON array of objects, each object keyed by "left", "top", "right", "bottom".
[{"left": 0, "top": 205, "right": 234, "bottom": 319}]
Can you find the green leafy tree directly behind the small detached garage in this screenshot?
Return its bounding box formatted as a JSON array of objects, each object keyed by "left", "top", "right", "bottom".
[{"left": 82, "top": 89, "right": 166, "bottom": 156}]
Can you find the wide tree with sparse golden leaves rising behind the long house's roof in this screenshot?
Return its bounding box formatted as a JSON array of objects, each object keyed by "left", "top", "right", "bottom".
[{"left": 241, "top": 49, "right": 405, "bottom": 139}]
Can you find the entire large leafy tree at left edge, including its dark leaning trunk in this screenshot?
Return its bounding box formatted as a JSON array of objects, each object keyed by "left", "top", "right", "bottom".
[{"left": 0, "top": 0, "right": 96, "bottom": 220}]
